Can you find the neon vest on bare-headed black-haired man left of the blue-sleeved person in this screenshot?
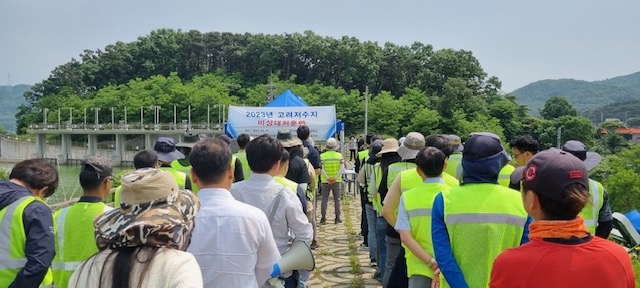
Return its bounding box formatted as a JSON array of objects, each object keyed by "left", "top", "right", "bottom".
[{"left": 402, "top": 183, "right": 450, "bottom": 279}]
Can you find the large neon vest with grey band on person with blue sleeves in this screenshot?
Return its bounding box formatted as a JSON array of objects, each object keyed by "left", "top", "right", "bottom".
[{"left": 440, "top": 183, "right": 527, "bottom": 287}]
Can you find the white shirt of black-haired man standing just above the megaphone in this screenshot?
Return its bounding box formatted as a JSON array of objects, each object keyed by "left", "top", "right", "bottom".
[{"left": 231, "top": 173, "right": 313, "bottom": 254}]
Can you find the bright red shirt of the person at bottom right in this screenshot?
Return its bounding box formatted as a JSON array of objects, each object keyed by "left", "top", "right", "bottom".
[{"left": 490, "top": 237, "right": 636, "bottom": 288}]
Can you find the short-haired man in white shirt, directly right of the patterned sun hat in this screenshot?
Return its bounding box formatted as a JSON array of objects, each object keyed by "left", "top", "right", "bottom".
[{"left": 187, "top": 138, "right": 282, "bottom": 288}]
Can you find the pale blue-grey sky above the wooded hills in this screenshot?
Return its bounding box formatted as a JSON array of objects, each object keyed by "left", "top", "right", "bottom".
[{"left": 0, "top": 0, "right": 640, "bottom": 92}]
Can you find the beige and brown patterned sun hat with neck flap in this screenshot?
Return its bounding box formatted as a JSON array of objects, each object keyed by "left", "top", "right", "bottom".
[{"left": 94, "top": 168, "right": 200, "bottom": 251}]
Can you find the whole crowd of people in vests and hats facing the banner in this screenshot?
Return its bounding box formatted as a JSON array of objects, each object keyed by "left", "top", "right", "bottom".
[{"left": 0, "top": 126, "right": 635, "bottom": 288}]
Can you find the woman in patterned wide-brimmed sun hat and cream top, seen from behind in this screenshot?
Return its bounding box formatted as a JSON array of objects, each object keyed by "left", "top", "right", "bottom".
[{"left": 69, "top": 168, "right": 202, "bottom": 288}]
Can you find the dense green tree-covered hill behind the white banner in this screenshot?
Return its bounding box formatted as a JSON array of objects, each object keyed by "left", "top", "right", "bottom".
[{"left": 11, "top": 29, "right": 640, "bottom": 209}]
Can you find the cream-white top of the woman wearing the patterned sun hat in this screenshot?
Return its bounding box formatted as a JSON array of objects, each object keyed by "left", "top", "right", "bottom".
[{"left": 69, "top": 248, "right": 202, "bottom": 288}]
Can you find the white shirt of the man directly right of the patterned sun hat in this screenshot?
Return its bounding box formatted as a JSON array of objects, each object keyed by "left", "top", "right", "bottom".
[{"left": 187, "top": 188, "right": 280, "bottom": 288}]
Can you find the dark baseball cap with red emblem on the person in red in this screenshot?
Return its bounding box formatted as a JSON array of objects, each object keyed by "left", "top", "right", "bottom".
[{"left": 511, "top": 148, "right": 589, "bottom": 200}]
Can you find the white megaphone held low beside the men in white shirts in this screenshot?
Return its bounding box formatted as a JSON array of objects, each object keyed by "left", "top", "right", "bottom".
[{"left": 271, "top": 240, "right": 316, "bottom": 277}]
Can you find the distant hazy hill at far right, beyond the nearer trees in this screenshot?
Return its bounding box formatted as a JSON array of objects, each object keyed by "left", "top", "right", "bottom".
[{"left": 511, "top": 72, "right": 640, "bottom": 116}]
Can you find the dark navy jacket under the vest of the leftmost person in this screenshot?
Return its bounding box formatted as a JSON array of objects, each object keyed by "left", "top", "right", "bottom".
[{"left": 0, "top": 181, "right": 56, "bottom": 288}]
